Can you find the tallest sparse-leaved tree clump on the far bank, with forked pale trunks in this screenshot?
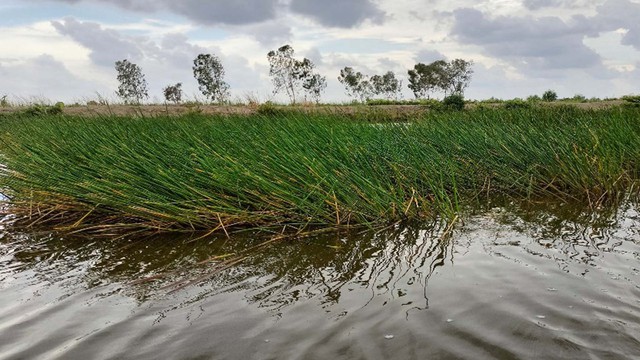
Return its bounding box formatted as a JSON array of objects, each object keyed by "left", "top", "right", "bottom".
[{"left": 267, "top": 45, "right": 326, "bottom": 103}]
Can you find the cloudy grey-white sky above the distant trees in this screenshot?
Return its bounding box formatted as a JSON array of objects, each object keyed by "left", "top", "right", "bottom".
[{"left": 0, "top": 0, "right": 640, "bottom": 103}]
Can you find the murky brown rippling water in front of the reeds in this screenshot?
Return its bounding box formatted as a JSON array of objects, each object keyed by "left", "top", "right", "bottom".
[{"left": 0, "top": 201, "right": 640, "bottom": 359}]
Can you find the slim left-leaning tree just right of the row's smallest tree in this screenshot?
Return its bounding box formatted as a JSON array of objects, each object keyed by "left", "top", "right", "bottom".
[{"left": 193, "top": 54, "right": 229, "bottom": 103}]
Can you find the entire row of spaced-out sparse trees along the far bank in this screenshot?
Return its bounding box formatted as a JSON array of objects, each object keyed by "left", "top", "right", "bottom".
[{"left": 115, "top": 45, "right": 473, "bottom": 104}]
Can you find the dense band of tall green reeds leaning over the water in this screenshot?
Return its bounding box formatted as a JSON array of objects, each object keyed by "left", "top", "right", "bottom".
[{"left": 0, "top": 107, "right": 640, "bottom": 231}]
